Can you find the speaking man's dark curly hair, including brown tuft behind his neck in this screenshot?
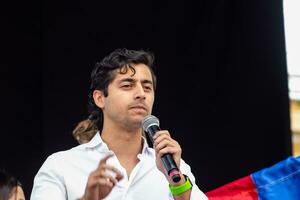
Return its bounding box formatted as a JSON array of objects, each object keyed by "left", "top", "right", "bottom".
[{"left": 73, "top": 49, "right": 156, "bottom": 144}]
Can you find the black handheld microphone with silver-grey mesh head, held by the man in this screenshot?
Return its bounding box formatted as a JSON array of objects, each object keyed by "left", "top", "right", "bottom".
[{"left": 143, "top": 115, "right": 181, "bottom": 183}]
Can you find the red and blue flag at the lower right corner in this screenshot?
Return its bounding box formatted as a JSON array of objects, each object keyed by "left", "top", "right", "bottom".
[{"left": 206, "top": 156, "right": 300, "bottom": 200}]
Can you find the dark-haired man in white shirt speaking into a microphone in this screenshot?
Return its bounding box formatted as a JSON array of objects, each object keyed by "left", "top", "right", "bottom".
[{"left": 31, "top": 49, "right": 207, "bottom": 200}]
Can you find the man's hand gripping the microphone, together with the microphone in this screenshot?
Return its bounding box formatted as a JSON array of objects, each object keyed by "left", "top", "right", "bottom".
[{"left": 143, "top": 115, "right": 181, "bottom": 183}]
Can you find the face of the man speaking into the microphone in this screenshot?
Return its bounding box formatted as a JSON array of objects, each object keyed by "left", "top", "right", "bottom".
[{"left": 102, "top": 64, "right": 154, "bottom": 129}]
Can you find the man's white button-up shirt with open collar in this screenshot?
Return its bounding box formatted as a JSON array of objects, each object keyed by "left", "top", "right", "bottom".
[{"left": 30, "top": 133, "right": 207, "bottom": 200}]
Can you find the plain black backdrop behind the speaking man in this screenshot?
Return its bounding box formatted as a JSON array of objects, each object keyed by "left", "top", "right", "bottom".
[{"left": 0, "top": 0, "right": 291, "bottom": 198}]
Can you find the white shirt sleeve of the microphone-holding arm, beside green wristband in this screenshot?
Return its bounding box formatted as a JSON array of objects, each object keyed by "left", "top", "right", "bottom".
[{"left": 171, "top": 160, "right": 208, "bottom": 200}]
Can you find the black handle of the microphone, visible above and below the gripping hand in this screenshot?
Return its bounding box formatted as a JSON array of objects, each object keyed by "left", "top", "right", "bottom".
[{"left": 147, "top": 125, "right": 181, "bottom": 183}]
